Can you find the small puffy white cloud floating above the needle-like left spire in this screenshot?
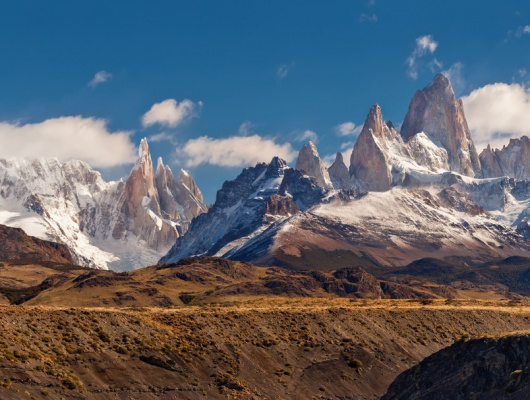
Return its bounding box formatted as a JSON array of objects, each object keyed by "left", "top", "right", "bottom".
[{"left": 142, "top": 99, "right": 198, "bottom": 128}]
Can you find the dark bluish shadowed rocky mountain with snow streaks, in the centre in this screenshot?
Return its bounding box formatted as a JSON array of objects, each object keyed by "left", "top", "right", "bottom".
[{"left": 160, "top": 157, "right": 326, "bottom": 263}]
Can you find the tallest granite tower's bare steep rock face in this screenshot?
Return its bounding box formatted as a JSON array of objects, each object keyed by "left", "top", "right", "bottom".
[{"left": 401, "top": 74, "right": 482, "bottom": 178}]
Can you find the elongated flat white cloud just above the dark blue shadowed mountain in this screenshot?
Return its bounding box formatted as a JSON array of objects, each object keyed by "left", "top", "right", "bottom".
[{"left": 177, "top": 135, "right": 297, "bottom": 168}]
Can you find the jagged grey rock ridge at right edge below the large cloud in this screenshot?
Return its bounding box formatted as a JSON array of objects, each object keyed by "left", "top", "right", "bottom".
[{"left": 480, "top": 136, "right": 530, "bottom": 180}]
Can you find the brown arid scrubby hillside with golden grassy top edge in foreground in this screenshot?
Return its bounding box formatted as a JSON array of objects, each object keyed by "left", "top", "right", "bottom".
[{"left": 0, "top": 299, "right": 530, "bottom": 400}]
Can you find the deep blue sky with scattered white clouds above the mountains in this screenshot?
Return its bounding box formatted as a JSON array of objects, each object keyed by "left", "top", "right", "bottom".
[{"left": 0, "top": 0, "right": 530, "bottom": 202}]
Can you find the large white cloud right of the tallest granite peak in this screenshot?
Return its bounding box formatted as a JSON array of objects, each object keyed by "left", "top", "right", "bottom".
[{"left": 462, "top": 83, "right": 530, "bottom": 150}]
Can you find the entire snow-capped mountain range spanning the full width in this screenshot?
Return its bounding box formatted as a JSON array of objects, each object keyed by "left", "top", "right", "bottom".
[{"left": 0, "top": 74, "right": 530, "bottom": 271}]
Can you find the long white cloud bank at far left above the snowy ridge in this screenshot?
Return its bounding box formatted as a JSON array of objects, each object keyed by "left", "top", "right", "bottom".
[{"left": 0, "top": 116, "right": 136, "bottom": 168}]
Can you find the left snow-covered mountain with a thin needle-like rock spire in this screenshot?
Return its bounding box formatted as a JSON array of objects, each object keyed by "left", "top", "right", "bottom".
[{"left": 0, "top": 139, "right": 207, "bottom": 269}]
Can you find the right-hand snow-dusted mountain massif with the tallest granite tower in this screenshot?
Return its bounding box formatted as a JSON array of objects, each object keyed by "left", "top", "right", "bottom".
[{"left": 161, "top": 75, "right": 530, "bottom": 268}]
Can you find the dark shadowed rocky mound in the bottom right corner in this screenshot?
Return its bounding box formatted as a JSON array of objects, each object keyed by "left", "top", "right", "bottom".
[{"left": 381, "top": 335, "right": 530, "bottom": 400}]
